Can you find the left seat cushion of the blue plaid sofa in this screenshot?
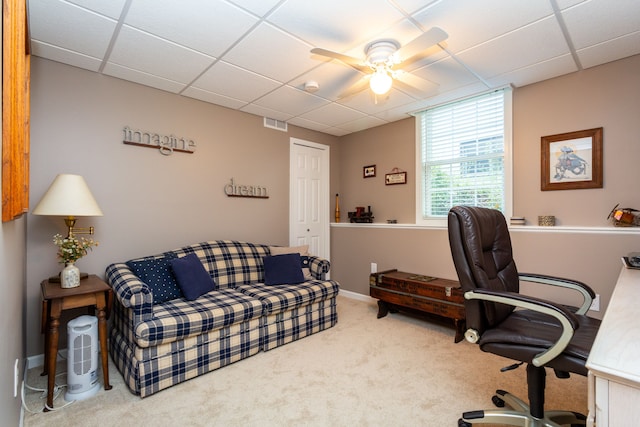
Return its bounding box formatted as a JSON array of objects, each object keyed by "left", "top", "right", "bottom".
[{"left": 133, "top": 289, "right": 263, "bottom": 347}]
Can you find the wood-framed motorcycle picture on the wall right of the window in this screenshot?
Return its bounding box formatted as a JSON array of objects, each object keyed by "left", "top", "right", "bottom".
[{"left": 540, "top": 128, "right": 602, "bottom": 191}]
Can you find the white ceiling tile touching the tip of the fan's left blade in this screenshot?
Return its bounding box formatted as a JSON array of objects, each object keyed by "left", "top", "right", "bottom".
[{"left": 222, "top": 24, "right": 318, "bottom": 83}]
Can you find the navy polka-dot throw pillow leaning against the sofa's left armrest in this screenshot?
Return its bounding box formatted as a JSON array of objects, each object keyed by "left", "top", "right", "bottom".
[{"left": 127, "top": 255, "right": 182, "bottom": 304}]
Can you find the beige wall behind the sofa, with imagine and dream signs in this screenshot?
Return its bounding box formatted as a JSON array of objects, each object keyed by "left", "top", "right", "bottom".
[{"left": 27, "top": 58, "right": 339, "bottom": 356}]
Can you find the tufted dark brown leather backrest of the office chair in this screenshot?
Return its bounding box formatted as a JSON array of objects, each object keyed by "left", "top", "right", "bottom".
[{"left": 448, "top": 206, "right": 520, "bottom": 334}]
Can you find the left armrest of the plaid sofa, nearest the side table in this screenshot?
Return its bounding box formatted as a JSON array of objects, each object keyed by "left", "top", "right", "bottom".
[{"left": 105, "top": 263, "right": 153, "bottom": 324}]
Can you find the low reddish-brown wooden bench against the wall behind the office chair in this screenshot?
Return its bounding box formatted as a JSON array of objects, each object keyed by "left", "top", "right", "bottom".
[{"left": 369, "top": 269, "right": 465, "bottom": 342}]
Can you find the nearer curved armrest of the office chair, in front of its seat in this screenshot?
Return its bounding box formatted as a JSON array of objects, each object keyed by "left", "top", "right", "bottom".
[{"left": 464, "top": 289, "right": 579, "bottom": 366}]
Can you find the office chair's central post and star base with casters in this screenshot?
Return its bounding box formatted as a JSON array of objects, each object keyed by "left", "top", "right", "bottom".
[{"left": 458, "top": 364, "right": 587, "bottom": 427}]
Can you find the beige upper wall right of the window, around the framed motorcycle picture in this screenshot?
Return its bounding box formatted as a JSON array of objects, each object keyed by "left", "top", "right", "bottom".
[{"left": 513, "top": 55, "right": 640, "bottom": 227}]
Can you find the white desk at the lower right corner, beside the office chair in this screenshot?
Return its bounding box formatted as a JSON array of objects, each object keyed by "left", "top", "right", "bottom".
[{"left": 586, "top": 267, "right": 640, "bottom": 427}]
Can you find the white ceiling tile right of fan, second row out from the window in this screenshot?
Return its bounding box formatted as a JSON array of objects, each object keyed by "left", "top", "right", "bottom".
[{"left": 457, "top": 17, "right": 569, "bottom": 79}]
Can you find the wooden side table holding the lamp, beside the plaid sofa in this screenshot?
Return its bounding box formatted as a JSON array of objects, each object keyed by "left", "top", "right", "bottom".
[{"left": 40, "top": 274, "right": 113, "bottom": 412}]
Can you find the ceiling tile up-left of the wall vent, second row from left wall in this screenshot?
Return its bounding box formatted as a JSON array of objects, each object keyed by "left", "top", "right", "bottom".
[{"left": 193, "top": 61, "right": 282, "bottom": 102}]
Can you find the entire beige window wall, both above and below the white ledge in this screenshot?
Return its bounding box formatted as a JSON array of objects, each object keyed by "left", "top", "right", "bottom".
[{"left": 331, "top": 56, "right": 640, "bottom": 314}]
